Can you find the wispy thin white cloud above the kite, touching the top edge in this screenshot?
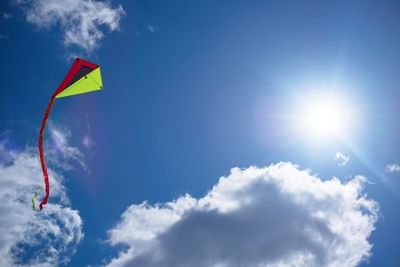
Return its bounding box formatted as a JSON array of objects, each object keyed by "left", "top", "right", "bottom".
[{"left": 17, "top": 0, "right": 125, "bottom": 52}]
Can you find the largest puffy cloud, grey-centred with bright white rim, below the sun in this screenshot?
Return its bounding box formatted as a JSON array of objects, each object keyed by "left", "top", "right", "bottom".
[{"left": 108, "top": 163, "right": 378, "bottom": 267}]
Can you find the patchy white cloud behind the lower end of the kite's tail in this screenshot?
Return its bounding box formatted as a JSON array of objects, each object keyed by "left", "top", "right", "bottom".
[{"left": 0, "top": 131, "right": 83, "bottom": 266}]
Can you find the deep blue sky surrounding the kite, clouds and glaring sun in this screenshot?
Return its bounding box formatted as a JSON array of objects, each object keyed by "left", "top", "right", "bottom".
[{"left": 0, "top": 1, "right": 400, "bottom": 266}]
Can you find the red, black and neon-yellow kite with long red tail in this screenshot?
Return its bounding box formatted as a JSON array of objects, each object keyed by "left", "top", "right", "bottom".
[{"left": 32, "top": 58, "right": 103, "bottom": 210}]
